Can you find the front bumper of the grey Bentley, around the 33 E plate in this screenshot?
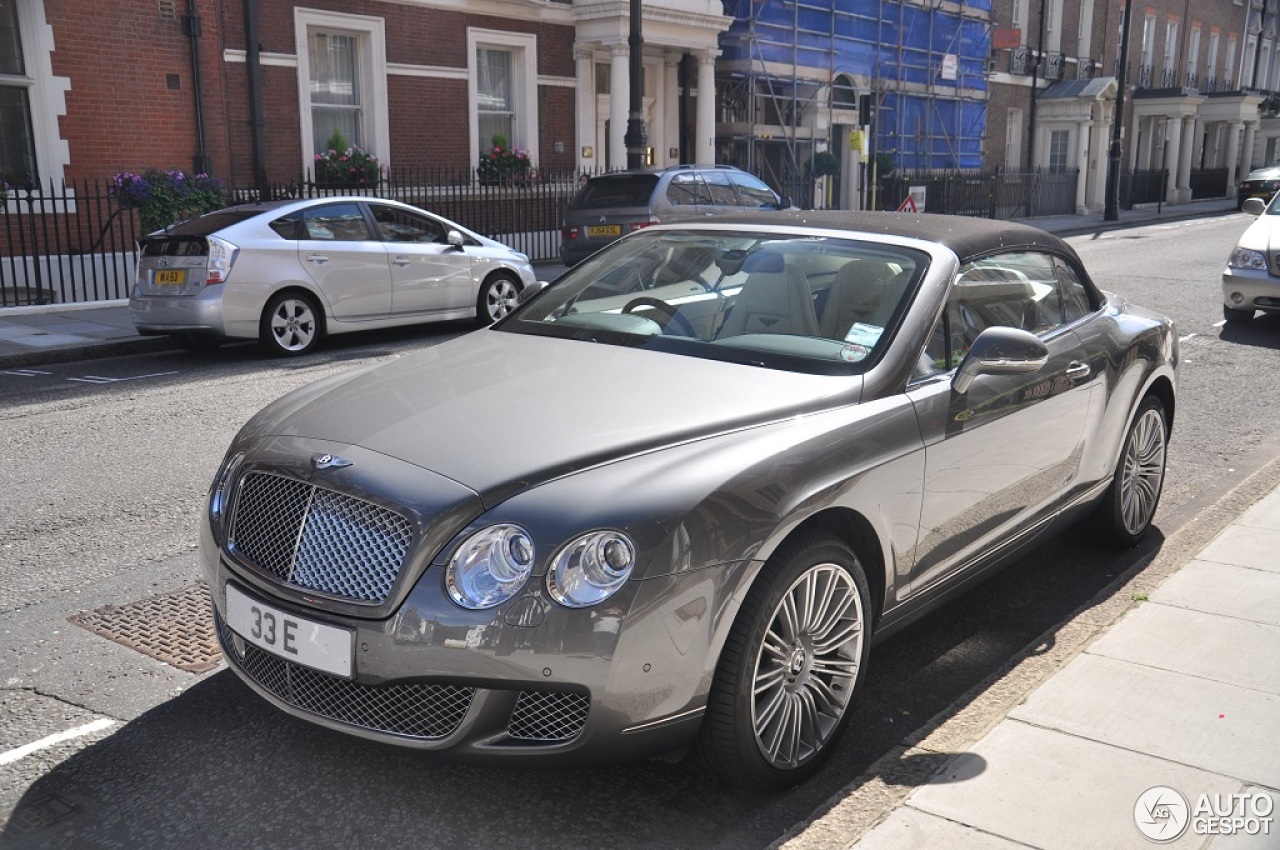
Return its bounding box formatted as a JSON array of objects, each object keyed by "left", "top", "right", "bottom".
[{"left": 205, "top": 539, "right": 756, "bottom": 763}]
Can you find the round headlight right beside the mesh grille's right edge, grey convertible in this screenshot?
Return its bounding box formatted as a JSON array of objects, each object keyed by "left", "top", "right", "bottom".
[{"left": 445, "top": 525, "right": 534, "bottom": 609}]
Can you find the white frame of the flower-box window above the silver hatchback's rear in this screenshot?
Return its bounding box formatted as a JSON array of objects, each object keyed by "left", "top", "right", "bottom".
[{"left": 293, "top": 8, "right": 392, "bottom": 172}]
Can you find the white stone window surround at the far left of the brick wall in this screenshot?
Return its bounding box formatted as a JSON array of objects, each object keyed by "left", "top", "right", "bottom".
[{"left": 0, "top": 0, "right": 72, "bottom": 197}]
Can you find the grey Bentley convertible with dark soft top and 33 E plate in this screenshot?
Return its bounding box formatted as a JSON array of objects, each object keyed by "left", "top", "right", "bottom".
[{"left": 202, "top": 211, "right": 1178, "bottom": 789}]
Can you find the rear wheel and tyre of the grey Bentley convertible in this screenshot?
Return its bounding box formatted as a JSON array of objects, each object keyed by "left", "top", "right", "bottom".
[{"left": 1096, "top": 396, "right": 1169, "bottom": 548}]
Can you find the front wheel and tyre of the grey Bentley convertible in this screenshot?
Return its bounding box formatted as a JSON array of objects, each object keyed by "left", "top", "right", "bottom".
[{"left": 692, "top": 534, "right": 870, "bottom": 790}]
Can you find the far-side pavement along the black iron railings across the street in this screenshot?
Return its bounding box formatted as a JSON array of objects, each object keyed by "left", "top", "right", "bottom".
[{"left": 0, "top": 198, "right": 1243, "bottom": 370}]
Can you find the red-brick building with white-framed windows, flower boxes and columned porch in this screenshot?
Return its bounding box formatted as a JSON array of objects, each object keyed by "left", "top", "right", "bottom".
[{"left": 0, "top": 0, "right": 728, "bottom": 193}]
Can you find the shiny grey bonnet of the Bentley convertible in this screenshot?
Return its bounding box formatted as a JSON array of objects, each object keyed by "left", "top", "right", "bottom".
[{"left": 242, "top": 330, "right": 861, "bottom": 507}]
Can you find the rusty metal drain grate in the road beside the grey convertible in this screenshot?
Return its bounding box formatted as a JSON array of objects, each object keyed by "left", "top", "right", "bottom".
[{"left": 67, "top": 581, "right": 223, "bottom": 673}]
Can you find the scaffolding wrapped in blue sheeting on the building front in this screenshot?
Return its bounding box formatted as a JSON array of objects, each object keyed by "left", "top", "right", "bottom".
[{"left": 717, "top": 0, "right": 991, "bottom": 195}]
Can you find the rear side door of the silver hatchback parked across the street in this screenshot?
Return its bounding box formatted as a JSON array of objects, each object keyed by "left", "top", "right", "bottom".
[{"left": 298, "top": 201, "right": 392, "bottom": 321}]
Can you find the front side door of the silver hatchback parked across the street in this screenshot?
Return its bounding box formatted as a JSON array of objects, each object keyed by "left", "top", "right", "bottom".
[{"left": 369, "top": 204, "right": 476, "bottom": 316}]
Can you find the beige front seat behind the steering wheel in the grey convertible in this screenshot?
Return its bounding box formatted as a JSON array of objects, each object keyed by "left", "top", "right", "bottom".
[{"left": 717, "top": 252, "right": 820, "bottom": 339}]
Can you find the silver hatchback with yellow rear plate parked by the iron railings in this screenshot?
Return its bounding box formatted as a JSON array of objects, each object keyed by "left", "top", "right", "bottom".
[{"left": 129, "top": 197, "right": 536, "bottom": 356}]
